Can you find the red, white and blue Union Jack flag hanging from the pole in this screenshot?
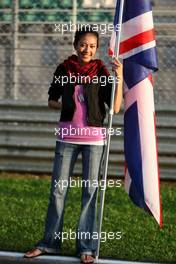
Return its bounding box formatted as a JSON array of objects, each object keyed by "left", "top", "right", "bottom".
[{"left": 109, "top": 0, "right": 162, "bottom": 226}]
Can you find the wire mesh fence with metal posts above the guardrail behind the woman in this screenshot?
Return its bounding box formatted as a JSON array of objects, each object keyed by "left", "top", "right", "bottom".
[{"left": 0, "top": 0, "right": 176, "bottom": 105}]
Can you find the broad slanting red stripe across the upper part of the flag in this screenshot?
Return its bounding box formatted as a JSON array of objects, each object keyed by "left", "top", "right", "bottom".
[{"left": 120, "top": 29, "right": 155, "bottom": 54}]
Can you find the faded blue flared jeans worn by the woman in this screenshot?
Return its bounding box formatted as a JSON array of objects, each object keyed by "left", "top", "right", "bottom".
[{"left": 36, "top": 141, "right": 104, "bottom": 255}]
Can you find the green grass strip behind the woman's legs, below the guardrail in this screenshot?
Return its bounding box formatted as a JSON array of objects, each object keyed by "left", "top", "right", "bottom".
[{"left": 0, "top": 173, "right": 176, "bottom": 263}]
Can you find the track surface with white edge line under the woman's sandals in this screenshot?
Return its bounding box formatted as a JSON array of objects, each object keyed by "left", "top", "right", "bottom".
[{"left": 0, "top": 251, "right": 159, "bottom": 264}]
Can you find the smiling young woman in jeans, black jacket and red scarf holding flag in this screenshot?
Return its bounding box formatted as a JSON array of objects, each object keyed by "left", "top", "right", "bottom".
[{"left": 25, "top": 25, "right": 122, "bottom": 263}]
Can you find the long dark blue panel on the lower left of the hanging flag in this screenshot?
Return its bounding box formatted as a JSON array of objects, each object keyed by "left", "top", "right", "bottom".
[{"left": 124, "top": 102, "right": 145, "bottom": 207}]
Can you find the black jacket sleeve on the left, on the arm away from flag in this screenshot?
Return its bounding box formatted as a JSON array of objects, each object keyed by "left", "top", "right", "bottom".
[{"left": 48, "top": 64, "right": 66, "bottom": 101}]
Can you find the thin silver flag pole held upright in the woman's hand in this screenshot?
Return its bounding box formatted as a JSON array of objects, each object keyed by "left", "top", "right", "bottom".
[{"left": 95, "top": 0, "right": 124, "bottom": 262}]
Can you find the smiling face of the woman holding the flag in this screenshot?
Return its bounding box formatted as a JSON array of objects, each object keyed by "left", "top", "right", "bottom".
[{"left": 75, "top": 33, "right": 97, "bottom": 65}]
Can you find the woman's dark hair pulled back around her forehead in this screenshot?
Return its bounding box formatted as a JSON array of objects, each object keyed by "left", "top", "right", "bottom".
[{"left": 73, "top": 24, "right": 99, "bottom": 48}]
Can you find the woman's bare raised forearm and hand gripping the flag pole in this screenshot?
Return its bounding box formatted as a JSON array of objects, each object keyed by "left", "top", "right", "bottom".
[{"left": 112, "top": 59, "right": 123, "bottom": 114}]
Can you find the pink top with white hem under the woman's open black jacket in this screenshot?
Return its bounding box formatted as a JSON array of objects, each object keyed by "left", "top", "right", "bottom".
[{"left": 57, "top": 85, "right": 106, "bottom": 144}]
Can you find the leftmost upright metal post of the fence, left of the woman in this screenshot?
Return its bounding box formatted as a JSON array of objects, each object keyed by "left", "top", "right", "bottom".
[{"left": 12, "top": 0, "right": 19, "bottom": 99}]
